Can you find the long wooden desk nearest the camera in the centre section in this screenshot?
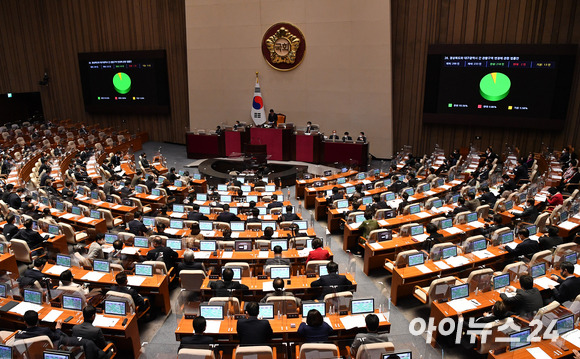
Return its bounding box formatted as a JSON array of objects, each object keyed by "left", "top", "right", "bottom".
[{"left": 175, "top": 310, "right": 391, "bottom": 343}]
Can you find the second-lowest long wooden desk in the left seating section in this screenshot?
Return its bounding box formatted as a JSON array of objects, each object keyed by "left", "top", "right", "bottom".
[{"left": 42, "top": 263, "right": 171, "bottom": 314}]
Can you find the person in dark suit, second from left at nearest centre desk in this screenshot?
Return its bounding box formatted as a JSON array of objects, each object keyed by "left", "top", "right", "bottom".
[{"left": 232, "top": 304, "right": 273, "bottom": 345}]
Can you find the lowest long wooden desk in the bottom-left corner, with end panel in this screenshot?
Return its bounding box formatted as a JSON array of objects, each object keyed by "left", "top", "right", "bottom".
[{"left": 0, "top": 298, "right": 141, "bottom": 358}]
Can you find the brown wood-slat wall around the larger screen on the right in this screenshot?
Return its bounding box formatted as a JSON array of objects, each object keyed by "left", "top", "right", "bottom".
[{"left": 392, "top": 0, "right": 580, "bottom": 158}]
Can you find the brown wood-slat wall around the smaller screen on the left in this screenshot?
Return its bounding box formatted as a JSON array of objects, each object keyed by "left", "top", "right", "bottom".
[{"left": 0, "top": 0, "right": 189, "bottom": 143}]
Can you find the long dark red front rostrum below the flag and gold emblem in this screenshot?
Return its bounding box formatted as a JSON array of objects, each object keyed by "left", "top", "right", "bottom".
[{"left": 186, "top": 127, "right": 369, "bottom": 168}]
